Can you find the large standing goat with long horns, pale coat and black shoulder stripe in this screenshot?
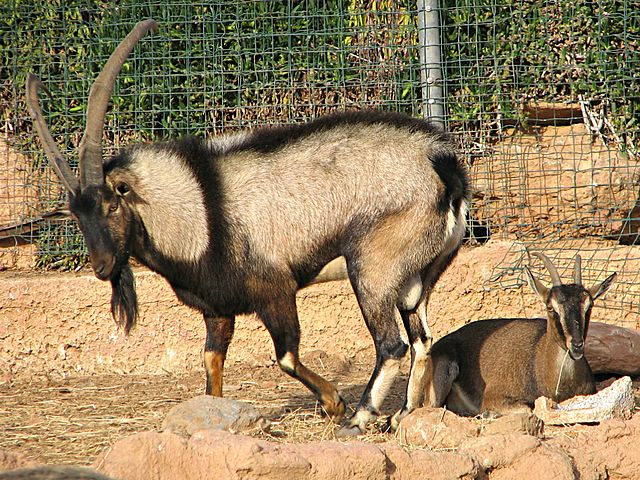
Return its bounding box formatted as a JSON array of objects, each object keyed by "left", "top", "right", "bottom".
[{"left": 27, "top": 20, "right": 468, "bottom": 434}]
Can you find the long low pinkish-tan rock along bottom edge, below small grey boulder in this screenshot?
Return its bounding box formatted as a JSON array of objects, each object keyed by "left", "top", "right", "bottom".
[{"left": 95, "top": 430, "right": 479, "bottom": 480}]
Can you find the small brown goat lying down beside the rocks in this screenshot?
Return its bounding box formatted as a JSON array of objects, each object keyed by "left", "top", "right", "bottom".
[{"left": 426, "top": 253, "right": 616, "bottom": 415}]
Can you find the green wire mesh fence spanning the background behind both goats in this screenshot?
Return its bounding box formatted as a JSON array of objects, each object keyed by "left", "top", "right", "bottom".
[{"left": 0, "top": 0, "right": 640, "bottom": 327}]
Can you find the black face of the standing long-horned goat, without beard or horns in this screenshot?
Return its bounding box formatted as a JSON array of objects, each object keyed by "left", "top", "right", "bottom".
[{"left": 70, "top": 184, "right": 131, "bottom": 280}]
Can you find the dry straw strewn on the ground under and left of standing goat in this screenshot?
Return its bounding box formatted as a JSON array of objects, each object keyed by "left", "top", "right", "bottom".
[{"left": 0, "top": 366, "right": 403, "bottom": 465}]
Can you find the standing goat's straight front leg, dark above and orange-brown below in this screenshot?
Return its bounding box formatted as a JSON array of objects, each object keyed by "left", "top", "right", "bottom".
[{"left": 204, "top": 315, "right": 235, "bottom": 397}]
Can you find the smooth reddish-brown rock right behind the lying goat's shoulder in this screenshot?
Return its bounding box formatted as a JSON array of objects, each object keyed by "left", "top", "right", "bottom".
[{"left": 585, "top": 322, "right": 640, "bottom": 377}]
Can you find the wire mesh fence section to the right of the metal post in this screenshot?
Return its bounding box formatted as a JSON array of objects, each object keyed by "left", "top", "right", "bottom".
[{"left": 443, "top": 0, "right": 640, "bottom": 328}]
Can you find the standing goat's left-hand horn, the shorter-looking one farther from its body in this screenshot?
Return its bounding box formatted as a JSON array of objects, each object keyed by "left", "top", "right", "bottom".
[{"left": 27, "top": 73, "right": 79, "bottom": 194}]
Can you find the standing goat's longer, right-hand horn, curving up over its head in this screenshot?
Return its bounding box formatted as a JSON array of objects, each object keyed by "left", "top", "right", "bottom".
[{"left": 79, "top": 20, "right": 158, "bottom": 188}]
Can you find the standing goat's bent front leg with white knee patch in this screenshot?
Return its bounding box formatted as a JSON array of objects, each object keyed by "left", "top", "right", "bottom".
[{"left": 257, "top": 292, "right": 345, "bottom": 421}]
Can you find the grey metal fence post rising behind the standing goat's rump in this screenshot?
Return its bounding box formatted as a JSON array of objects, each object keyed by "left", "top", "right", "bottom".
[{"left": 417, "top": 0, "right": 445, "bottom": 127}]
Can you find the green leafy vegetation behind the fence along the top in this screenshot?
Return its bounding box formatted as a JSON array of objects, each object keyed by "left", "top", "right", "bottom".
[{"left": 0, "top": 0, "right": 640, "bottom": 267}]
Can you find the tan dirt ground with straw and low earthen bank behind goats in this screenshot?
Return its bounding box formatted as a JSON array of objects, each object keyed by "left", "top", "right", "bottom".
[{"left": 0, "top": 242, "right": 640, "bottom": 465}]
